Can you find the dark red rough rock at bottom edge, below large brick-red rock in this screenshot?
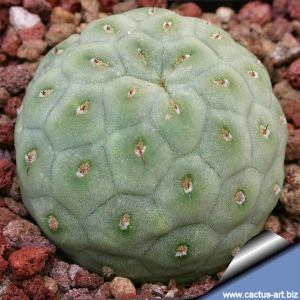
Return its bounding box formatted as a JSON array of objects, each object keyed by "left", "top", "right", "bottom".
[{"left": 22, "top": 275, "right": 57, "bottom": 300}]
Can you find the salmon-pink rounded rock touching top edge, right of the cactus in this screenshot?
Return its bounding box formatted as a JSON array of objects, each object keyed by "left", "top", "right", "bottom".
[{"left": 237, "top": 1, "right": 272, "bottom": 25}]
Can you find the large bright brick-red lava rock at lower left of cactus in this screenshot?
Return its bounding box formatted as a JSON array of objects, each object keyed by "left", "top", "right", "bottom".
[{"left": 8, "top": 248, "right": 50, "bottom": 278}]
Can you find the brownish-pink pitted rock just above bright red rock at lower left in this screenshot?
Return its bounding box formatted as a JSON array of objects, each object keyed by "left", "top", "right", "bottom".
[{"left": 3, "top": 219, "right": 39, "bottom": 248}]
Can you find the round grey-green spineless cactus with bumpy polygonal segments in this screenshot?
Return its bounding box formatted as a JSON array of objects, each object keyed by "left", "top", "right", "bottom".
[{"left": 15, "top": 8, "right": 287, "bottom": 282}]
